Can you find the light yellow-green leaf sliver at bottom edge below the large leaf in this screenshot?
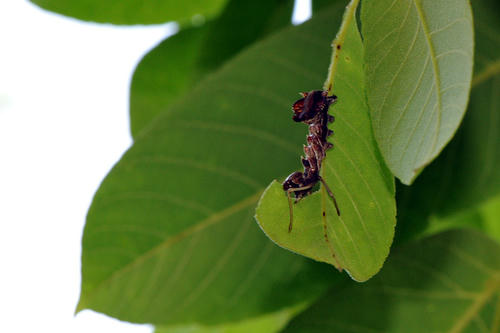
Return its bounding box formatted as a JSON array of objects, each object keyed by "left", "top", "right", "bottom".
[{"left": 155, "top": 305, "right": 304, "bottom": 333}]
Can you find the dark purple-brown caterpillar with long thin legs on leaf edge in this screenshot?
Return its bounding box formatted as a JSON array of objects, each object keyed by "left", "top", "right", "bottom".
[{"left": 283, "top": 90, "right": 340, "bottom": 232}]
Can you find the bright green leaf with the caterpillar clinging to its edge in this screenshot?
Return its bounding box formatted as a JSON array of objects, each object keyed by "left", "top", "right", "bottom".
[{"left": 256, "top": 1, "right": 396, "bottom": 281}]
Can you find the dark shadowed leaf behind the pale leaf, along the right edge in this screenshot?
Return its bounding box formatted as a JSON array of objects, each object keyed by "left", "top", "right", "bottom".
[{"left": 396, "top": 0, "right": 500, "bottom": 239}]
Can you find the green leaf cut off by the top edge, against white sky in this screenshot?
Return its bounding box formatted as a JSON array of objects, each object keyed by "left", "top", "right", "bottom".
[{"left": 30, "top": 0, "right": 227, "bottom": 24}]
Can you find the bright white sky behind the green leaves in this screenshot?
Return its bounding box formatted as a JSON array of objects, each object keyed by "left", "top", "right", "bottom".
[{"left": 0, "top": 0, "right": 310, "bottom": 333}]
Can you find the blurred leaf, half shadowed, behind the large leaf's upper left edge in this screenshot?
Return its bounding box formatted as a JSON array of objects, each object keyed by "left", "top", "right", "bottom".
[{"left": 130, "top": 0, "right": 293, "bottom": 137}]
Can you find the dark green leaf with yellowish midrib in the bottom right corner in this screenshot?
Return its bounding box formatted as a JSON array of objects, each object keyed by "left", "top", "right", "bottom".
[{"left": 284, "top": 231, "right": 500, "bottom": 333}]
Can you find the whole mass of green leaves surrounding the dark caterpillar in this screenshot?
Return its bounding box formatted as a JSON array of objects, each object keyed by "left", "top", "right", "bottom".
[{"left": 33, "top": 0, "right": 500, "bottom": 333}]
